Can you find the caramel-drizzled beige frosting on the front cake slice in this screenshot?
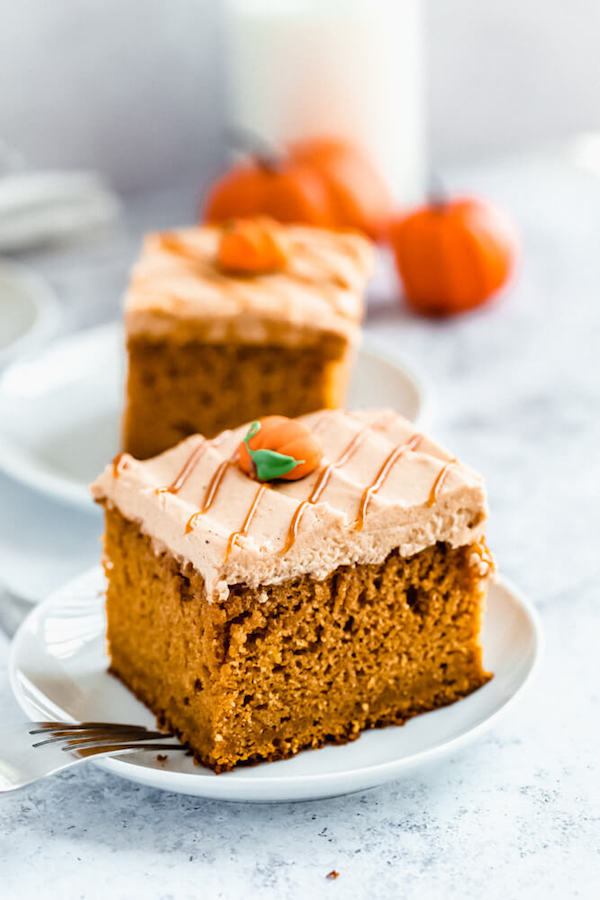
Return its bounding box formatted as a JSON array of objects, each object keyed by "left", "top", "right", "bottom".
[{"left": 91, "top": 410, "right": 487, "bottom": 599}]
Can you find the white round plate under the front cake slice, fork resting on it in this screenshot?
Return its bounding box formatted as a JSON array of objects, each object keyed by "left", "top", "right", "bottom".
[{"left": 9, "top": 568, "right": 541, "bottom": 802}]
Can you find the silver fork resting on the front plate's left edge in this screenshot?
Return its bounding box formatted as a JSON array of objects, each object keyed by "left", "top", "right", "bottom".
[{"left": 0, "top": 722, "right": 186, "bottom": 794}]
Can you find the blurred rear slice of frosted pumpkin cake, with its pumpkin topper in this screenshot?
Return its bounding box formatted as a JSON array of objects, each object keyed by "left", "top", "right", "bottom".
[{"left": 123, "top": 219, "right": 374, "bottom": 458}]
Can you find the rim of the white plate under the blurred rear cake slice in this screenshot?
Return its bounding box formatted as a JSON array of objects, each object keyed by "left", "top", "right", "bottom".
[{"left": 0, "top": 322, "right": 432, "bottom": 512}]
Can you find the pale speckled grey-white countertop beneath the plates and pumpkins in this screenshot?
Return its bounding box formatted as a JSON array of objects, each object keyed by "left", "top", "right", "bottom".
[{"left": 0, "top": 156, "right": 600, "bottom": 900}]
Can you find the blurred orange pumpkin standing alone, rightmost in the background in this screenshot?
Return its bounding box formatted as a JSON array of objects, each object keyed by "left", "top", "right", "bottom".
[{"left": 388, "top": 197, "right": 517, "bottom": 316}]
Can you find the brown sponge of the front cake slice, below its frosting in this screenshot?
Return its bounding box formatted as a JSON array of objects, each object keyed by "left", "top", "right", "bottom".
[{"left": 106, "top": 510, "right": 490, "bottom": 772}]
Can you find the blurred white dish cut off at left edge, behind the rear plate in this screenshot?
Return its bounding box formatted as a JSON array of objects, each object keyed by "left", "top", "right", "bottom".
[{"left": 0, "top": 259, "right": 59, "bottom": 368}]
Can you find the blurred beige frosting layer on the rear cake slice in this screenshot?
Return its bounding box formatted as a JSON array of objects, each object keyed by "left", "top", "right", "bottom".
[{"left": 125, "top": 225, "right": 375, "bottom": 344}]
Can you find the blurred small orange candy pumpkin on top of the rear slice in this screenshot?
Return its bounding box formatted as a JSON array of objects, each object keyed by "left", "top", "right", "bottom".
[{"left": 217, "top": 217, "right": 287, "bottom": 275}]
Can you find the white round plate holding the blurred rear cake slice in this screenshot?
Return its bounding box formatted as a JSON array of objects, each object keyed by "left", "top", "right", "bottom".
[{"left": 0, "top": 325, "right": 425, "bottom": 509}]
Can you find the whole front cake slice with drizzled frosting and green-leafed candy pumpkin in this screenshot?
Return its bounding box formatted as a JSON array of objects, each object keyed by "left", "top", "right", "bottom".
[{"left": 92, "top": 410, "right": 493, "bottom": 772}]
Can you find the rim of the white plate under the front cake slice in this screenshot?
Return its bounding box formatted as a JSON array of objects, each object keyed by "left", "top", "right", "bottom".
[{"left": 8, "top": 566, "right": 544, "bottom": 802}]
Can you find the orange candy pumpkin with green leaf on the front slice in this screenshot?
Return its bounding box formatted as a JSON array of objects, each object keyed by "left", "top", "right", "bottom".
[{"left": 237, "top": 416, "right": 323, "bottom": 481}]
